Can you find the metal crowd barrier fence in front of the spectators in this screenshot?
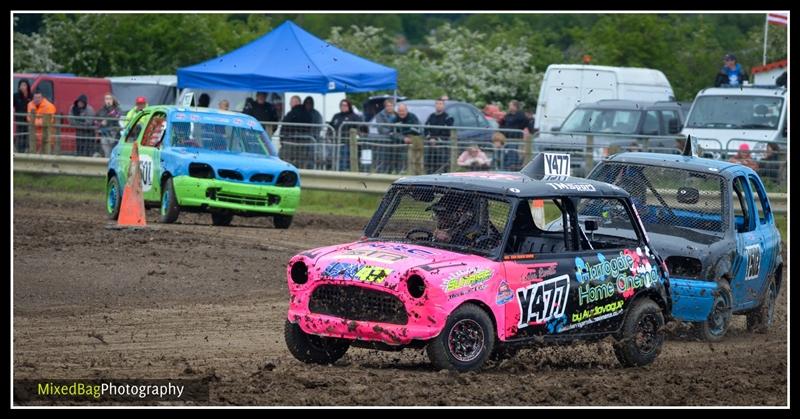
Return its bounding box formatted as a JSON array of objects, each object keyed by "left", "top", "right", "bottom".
[{"left": 13, "top": 114, "right": 788, "bottom": 186}]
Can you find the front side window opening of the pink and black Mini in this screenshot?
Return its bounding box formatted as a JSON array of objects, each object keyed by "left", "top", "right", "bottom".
[{"left": 505, "top": 199, "right": 573, "bottom": 254}]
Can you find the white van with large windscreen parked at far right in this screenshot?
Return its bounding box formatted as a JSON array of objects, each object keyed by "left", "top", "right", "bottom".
[{"left": 681, "top": 85, "right": 787, "bottom": 158}]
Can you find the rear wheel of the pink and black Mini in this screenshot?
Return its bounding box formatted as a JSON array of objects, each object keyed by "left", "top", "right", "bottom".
[{"left": 614, "top": 298, "right": 664, "bottom": 367}]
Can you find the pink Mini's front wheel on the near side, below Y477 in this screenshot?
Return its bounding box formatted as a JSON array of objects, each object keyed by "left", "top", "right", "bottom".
[{"left": 427, "top": 304, "right": 494, "bottom": 372}]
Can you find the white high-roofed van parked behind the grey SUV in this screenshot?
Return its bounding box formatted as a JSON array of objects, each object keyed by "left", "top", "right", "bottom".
[{"left": 534, "top": 64, "right": 675, "bottom": 132}]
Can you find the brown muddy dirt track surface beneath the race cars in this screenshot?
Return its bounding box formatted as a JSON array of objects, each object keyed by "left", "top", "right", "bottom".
[{"left": 13, "top": 190, "right": 788, "bottom": 406}]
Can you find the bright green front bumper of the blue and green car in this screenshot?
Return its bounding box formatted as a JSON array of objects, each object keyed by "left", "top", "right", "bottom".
[{"left": 172, "top": 176, "right": 300, "bottom": 215}]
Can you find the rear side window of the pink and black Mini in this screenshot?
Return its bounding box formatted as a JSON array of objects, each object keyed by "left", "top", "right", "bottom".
[{"left": 578, "top": 198, "right": 639, "bottom": 250}]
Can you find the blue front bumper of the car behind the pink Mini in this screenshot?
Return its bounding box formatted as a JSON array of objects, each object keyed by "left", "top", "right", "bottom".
[{"left": 669, "top": 277, "right": 717, "bottom": 322}]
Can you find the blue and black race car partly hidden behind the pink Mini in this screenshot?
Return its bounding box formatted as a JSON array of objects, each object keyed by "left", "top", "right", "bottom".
[{"left": 589, "top": 139, "right": 783, "bottom": 341}]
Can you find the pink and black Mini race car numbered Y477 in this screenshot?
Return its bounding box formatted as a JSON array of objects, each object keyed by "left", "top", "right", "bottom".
[{"left": 285, "top": 155, "right": 671, "bottom": 371}]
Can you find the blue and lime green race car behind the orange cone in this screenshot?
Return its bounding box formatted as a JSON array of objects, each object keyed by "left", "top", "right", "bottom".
[{"left": 106, "top": 106, "right": 300, "bottom": 228}]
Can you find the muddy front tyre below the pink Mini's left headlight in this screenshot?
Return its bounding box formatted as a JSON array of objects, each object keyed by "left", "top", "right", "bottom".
[{"left": 284, "top": 320, "right": 350, "bottom": 364}]
